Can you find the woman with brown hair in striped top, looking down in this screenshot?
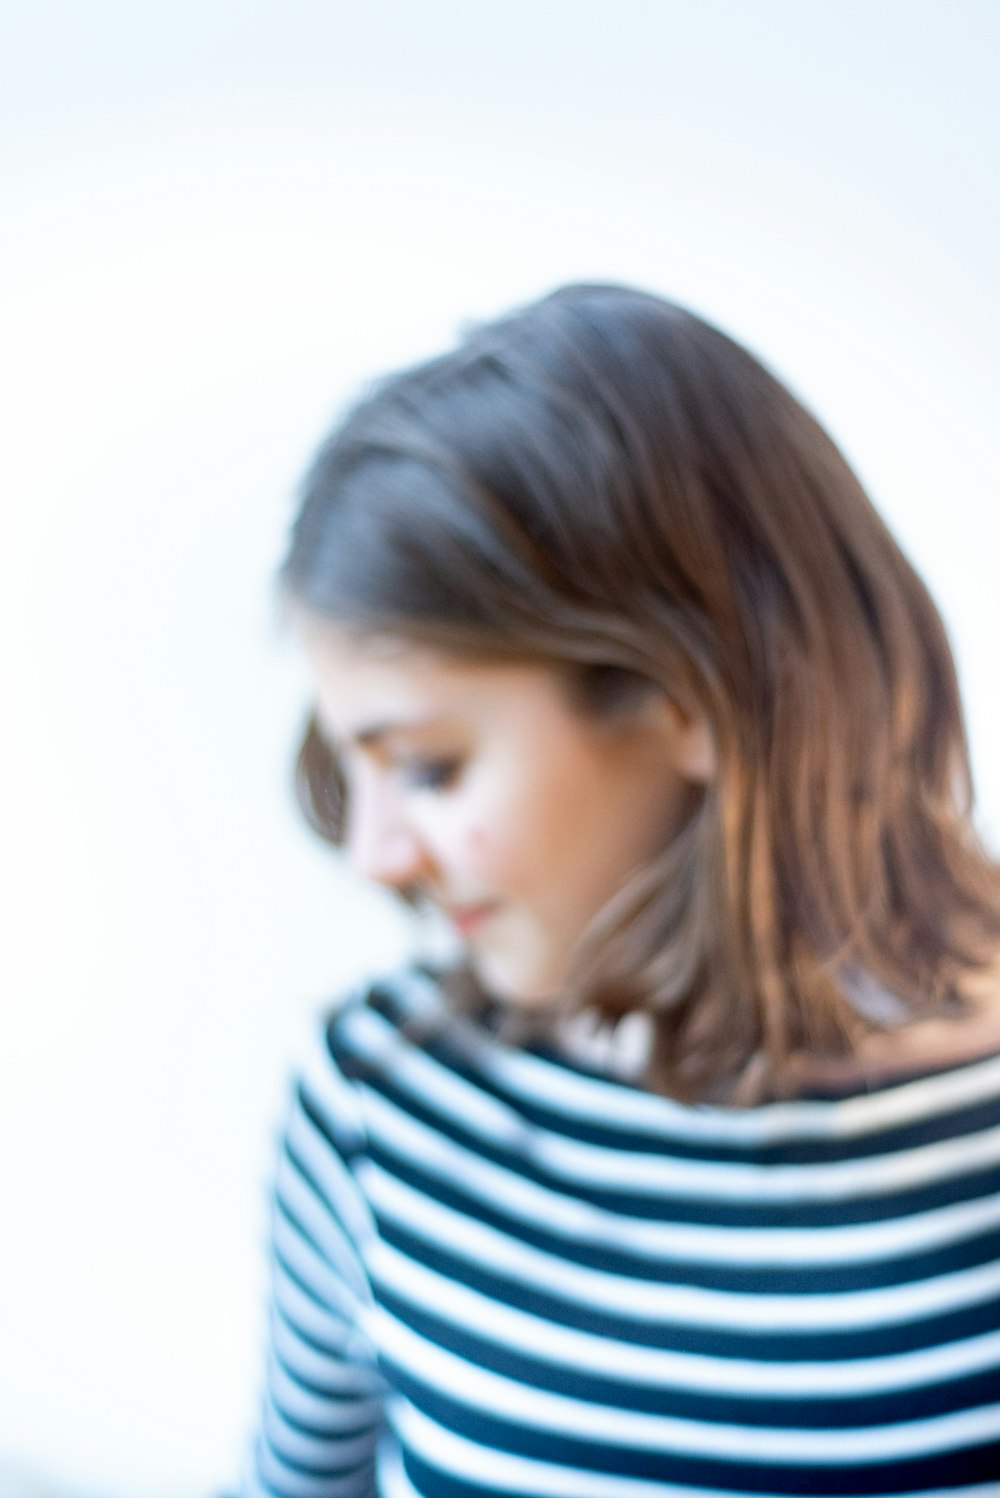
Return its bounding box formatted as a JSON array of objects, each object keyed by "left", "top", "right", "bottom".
[{"left": 247, "top": 286, "right": 1000, "bottom": 1498}]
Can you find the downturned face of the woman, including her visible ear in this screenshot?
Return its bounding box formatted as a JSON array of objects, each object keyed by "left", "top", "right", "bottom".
[{"left": 305, "top": 625, "right": 711, "bottom": 1002}]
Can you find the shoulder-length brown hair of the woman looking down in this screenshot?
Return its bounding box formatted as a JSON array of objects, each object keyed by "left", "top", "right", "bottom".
[{"left": 281, "top": 286, "right": 1000, "bottom": 1097}]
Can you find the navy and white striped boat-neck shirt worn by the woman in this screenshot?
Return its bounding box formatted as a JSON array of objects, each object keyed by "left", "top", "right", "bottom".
[{"left": 244, "top": 971, "right": 1000, "bottom": 1498}]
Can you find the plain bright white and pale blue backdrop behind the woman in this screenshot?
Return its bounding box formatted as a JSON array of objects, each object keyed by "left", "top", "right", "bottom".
[{"left": 0, "top": 0, "right": 1000, "bottom": 1498}]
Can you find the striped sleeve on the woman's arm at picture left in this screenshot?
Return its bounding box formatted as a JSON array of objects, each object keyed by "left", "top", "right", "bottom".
[{"left": 243, "top": 1022, "right": 385, "bottom": 1498}]
